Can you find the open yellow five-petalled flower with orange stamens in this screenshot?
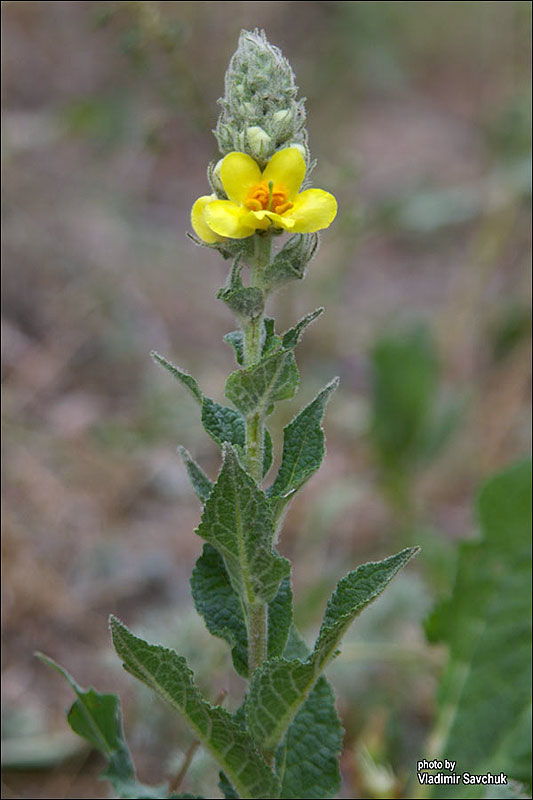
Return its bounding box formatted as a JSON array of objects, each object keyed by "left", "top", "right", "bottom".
[{"left": 191, "top": 147, "right": 337, "bottom": 244}]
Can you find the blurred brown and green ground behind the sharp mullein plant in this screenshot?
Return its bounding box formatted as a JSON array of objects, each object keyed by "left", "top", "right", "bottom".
[{"left": 2, "top": 0, "right": 531, "bottom": 798}]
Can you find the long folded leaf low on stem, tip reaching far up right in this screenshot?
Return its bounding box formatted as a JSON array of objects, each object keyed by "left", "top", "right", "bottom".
[{"left": 246, "top": 547, "right": 418, "bottom": 751}]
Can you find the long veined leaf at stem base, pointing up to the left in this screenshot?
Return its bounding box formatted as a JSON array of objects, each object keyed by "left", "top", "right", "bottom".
[{"left": 110, "top": 617, "right": 279, "bottom": 798}]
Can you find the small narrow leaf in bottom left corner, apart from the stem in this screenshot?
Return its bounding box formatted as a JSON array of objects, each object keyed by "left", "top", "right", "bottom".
[{"left": 36, "top": 653, "right": 162, "bottom": 798}]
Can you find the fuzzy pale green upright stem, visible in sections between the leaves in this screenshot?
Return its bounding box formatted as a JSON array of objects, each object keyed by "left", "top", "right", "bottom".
[{"left": 243, "top": 234, "right": 272, "bottom": 677}]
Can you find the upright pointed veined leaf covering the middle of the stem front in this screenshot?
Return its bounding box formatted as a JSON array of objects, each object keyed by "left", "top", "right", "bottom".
[{"left": 196, "top": 445, "right": 290, "bottom": 606}]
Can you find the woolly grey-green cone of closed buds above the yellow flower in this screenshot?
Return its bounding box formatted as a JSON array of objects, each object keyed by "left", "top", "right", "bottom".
[{"left": 214, "top": 29, "right": 310, "bottom": 171}]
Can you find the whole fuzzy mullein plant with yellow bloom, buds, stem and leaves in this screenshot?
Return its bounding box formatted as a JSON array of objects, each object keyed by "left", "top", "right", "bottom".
[{"left": 41, "top": 30, "right": 417, "bottom": 798}]
